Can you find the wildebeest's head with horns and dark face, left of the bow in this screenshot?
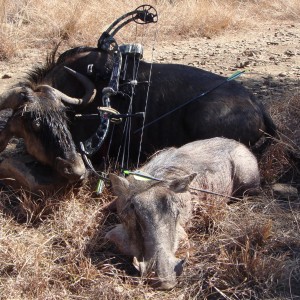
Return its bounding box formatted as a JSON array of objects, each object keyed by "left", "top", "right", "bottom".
[{"left": 0, "top": 68, "right": 94, "bottom": 182}]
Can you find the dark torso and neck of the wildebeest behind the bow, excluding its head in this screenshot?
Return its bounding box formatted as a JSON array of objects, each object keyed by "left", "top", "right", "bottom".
[{"left": 50, "top": 47, "right": 275, "bottom": 160}]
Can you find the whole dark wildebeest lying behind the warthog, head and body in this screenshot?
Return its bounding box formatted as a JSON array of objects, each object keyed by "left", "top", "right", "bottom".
[{"left": 0, "top": 47, "right": 275, "bottom": 186}]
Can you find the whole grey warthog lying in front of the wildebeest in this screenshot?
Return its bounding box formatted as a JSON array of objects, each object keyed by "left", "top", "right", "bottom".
[{"left": 106, "top": 138, "right": 260, "bottom": 289}]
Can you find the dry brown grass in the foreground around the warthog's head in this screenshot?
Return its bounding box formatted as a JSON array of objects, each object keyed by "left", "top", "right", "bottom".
[{"left": 0, "top": 171, "right": 300, "bottom": 299}]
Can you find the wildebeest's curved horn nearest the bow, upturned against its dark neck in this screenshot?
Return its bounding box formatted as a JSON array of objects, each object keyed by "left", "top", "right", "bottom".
[{"left": 52, "top": 66, "right": 97, "bottom": 105}]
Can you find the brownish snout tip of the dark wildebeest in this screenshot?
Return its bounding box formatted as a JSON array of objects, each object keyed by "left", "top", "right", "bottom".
[{"left": 55, "top": 153, "right": 87, "bottom": 183}]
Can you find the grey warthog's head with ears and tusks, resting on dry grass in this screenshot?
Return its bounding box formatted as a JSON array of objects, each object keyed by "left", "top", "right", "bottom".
[{"left": 106, "top": 174, "right": 196, "bottom": 289}]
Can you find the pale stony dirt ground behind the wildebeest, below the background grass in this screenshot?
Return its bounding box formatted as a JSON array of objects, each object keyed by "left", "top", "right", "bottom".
[{"left": 0, "top": 22, "right": 300, "bottom": 99}]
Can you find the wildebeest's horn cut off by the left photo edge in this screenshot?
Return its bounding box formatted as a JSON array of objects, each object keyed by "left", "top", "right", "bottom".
[{"left": 0, "top": 87, "right": 26, "bottom": 111}]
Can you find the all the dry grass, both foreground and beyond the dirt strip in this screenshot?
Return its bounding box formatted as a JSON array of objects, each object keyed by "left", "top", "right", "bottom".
[{"left": 0, "top": 0, "right": 300, "bottom": 300}]
